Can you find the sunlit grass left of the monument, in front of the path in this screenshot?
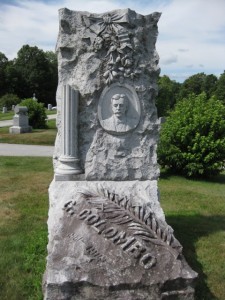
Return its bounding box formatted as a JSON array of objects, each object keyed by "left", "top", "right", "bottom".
[{"left": 0, "top": 157, "right": 53, "bottom": 300}]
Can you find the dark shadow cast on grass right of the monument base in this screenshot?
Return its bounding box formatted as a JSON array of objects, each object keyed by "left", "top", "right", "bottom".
[{"left": 166, "top": 215, "right": 225, "bottom": 300}]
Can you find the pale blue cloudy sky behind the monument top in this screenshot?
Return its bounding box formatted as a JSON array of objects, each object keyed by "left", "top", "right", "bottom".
[{"left": 0, "top": 0, "right": 225, "bottom": 82}]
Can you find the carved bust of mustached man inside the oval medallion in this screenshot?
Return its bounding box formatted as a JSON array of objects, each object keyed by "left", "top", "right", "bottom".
[{"left": 101, "top": 94, "right": 137, "bottom": 133}]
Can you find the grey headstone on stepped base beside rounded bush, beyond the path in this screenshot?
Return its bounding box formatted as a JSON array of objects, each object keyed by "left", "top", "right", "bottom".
[{"left": 9, "top": 105, "right": 32, "bottom": 134}]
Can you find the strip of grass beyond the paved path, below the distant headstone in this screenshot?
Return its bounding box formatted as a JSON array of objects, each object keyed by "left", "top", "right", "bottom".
[{"left": 0, "top": 120, "right": 57, "bottom": 146}]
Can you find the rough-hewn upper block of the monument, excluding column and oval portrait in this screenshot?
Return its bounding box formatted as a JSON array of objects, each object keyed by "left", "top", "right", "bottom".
[{"left": 55, "top": 9, "right": 160, "bottom": 180}]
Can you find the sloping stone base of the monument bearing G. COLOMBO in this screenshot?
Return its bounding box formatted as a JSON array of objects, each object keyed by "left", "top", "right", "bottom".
[{"left": 43, "top": 180, "right": 197, "bottom": 300}]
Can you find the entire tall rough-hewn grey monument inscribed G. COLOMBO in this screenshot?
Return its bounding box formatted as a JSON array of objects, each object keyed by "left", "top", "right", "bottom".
[{"left": 43, "top": 9, "right": 197, "bottom": 300}]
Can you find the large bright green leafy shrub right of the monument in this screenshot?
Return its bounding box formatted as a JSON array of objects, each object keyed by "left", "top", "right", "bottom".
[{"left": 158, "top": 93, "right": 225, "bottom": 176}]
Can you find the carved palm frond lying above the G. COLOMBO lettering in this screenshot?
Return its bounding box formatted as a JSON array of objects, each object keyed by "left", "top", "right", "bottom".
[{"left": 78, "top": 189, "right": 182, "bottom": 257}]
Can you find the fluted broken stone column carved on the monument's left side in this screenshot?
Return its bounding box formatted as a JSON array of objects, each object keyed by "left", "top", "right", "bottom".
[{"left": 55, "top": 85, "right": 82, "bottom": 180}]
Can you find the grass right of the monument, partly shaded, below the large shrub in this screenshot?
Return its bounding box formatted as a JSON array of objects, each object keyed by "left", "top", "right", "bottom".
[{"left": 159, "top": 174, "right": 225, "bottom": 300}]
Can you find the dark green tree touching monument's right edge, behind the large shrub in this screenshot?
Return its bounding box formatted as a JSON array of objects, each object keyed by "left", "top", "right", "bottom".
[{"left": 156, "top": 75, "right": 181, "bottom": 117}]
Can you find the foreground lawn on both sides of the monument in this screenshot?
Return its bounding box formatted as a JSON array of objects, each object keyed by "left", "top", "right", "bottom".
[{"left": 0, "top": 157, "right": 225, "bottom": 300}]
